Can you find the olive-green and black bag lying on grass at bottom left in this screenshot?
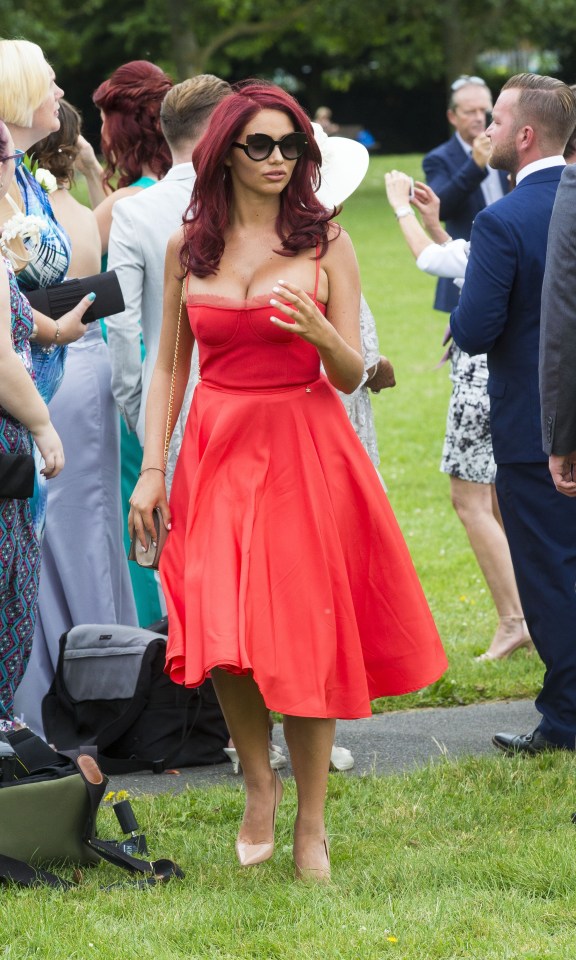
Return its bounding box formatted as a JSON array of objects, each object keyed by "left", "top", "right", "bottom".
[{"left": 0, "top": 729, "right": 183, "bottom": 889}]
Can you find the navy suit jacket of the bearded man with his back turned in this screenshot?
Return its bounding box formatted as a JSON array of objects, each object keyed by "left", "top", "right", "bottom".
[{"left": 450, "top": 166, "right": 564, "bottom": 463}]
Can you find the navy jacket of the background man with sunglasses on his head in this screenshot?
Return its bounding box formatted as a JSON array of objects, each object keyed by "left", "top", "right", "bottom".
[{"left": 422, "top": 134, "right": 509, "bottom": 313}]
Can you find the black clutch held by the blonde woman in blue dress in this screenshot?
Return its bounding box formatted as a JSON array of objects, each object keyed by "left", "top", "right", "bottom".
[{"left": 26, "top": 270, "right": 125, "bottom": 323}]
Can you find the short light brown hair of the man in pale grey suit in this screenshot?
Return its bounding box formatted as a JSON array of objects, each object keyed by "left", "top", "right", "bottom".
[{"left": 160, "top": 73, "right": 232, "bottom": 146}]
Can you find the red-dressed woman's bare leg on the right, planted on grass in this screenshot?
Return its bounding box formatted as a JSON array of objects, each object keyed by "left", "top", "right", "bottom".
[{"left": 284, "top": 717, "right": 336, "bottom": 880}]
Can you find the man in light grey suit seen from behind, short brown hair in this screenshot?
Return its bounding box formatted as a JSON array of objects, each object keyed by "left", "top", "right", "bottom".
[{"left": 106, "top": 74, "right": 230, "bottom": 444}]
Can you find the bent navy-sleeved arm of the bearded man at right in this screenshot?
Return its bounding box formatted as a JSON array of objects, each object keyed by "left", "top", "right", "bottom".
[{"left": 450, "top": 207, "right": 517, "bottom": 355}]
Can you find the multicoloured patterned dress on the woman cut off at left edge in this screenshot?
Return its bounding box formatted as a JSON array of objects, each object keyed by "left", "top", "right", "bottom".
[{"left": 0, "top": 261, "right": 40, "bottom": 722}]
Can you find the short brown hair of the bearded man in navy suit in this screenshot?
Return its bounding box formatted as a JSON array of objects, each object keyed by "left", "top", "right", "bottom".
[{"left": 502, "top": 73, "right": 576, "bottom": 153}]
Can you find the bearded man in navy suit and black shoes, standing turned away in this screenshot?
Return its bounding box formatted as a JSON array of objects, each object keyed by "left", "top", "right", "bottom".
[{"left": 450, "top": 74, "right": 576, "bottom": 754}]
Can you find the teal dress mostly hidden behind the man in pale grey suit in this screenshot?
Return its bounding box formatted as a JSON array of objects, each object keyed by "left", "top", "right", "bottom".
[{"left": 101, "top": 177, "right": 162, "bottom": 627}]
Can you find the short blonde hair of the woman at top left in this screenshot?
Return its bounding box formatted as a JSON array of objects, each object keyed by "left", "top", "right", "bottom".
[{"left": 0, "top": 40, "right": 52, "bottom": 127}]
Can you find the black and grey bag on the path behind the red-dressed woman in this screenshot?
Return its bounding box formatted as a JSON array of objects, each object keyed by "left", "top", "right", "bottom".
[{"left": 42, "top": 624, "right": 229, "bottom": 774}]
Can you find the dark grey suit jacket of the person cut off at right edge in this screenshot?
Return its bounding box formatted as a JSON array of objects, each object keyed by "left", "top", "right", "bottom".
[{"left": 540, "top": 165, "right": 576, "bottom": 455}]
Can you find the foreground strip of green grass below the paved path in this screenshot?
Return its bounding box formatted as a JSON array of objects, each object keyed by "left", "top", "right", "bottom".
[{"left": 0, "top": 755, "right": 576, "bottom": 960}]
